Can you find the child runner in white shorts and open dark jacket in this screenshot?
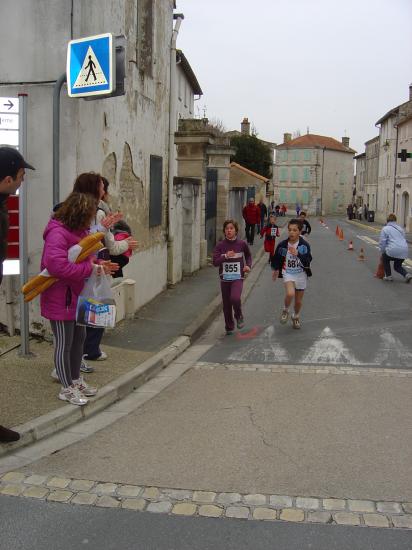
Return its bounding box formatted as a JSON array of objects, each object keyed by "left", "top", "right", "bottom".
[{"left": 271, "top": 219, "right": 312, "bottom": 329}]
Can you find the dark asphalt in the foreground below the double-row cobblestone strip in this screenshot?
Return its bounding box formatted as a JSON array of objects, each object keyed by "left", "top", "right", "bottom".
[{"left": 0, "top": 496, "right": 411, "bottom": 550}]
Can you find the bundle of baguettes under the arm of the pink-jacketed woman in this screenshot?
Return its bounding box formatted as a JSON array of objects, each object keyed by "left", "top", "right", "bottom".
[{"left": 21, "top": 231, "right": 104, "bottom": 302}]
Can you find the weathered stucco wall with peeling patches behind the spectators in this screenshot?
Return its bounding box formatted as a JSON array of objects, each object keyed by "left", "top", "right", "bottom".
[{"left": 0, "top": 0, "right": 173, "bottom": 332}]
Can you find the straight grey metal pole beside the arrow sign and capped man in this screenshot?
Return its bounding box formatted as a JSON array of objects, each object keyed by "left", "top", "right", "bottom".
[{"left": 18, "top": 94, "right": 30, "bottom": 357}]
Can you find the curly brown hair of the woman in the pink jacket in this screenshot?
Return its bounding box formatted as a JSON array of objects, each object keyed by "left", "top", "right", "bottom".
[{"left": 53, "top": 191, "right": 98, "bottom": 231}]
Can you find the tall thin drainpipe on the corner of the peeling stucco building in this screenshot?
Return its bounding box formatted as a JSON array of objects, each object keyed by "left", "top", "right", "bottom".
[{"left": 167, "top": 13, "right": 184, "bottom": 282}]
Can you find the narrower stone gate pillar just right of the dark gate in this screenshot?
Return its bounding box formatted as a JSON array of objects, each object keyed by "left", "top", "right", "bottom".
[{"left": 207, "top": 137, "right": 235, "bottom": 240}]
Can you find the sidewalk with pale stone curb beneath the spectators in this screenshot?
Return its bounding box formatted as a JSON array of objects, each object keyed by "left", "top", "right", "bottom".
[{"left": 0, "top": 245, "right": 264, "bottom": 455}]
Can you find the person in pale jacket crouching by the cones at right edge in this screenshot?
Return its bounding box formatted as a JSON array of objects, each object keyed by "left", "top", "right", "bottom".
[{"left": 379, "top": 214, "right": 412, "bottom": 283}]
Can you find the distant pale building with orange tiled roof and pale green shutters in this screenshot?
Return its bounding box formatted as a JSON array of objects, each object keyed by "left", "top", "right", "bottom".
[{"left": 274, "top": 133, "right": 355, "bottom": 215}]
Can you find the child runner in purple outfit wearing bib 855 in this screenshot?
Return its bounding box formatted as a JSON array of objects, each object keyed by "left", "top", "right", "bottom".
[{"left": 213, "top": 220, "right": 252, "bottom": 334}]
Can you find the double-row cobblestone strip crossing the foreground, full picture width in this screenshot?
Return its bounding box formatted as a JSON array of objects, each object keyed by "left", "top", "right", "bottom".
[{"left": 0, "top": 472, "right": 412, "bottom": 529}]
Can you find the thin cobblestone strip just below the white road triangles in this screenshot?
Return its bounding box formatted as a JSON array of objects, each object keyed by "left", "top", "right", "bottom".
[{"left": 193, "top": 361, "right": 412, "bottom": 378}]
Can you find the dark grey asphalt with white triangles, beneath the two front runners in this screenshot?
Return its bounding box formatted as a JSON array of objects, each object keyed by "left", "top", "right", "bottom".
[{"left": 202, "top": 218, "right": 412, "bottom": 369}]
